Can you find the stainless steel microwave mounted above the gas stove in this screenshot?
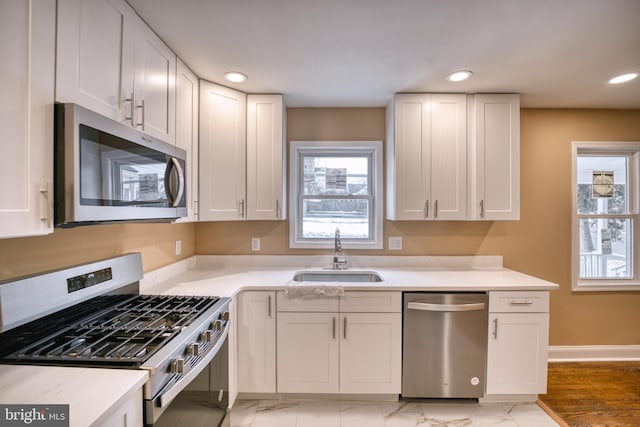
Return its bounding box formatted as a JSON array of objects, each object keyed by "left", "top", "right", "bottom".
[{"left": 54, "top": 104, "right": 187, "bottom": 227}]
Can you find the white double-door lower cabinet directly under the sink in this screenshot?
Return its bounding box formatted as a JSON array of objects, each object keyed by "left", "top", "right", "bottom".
[{"left": 277, "top": 292, "right": 402, "bottom": 394}]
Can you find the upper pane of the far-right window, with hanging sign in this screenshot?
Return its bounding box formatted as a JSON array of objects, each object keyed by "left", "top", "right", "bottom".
[{"left": 577, "top": 156, "right": 629, "bottom": 214}]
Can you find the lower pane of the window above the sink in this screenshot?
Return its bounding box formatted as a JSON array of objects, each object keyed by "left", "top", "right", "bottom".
[{"left": 302, "top": 199, "right": 370, "bottom": 239}]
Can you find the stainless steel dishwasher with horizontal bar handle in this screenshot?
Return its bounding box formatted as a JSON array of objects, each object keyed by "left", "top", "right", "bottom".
[{"left": 402, "top": 292, "right": 488, "bottom": 398}]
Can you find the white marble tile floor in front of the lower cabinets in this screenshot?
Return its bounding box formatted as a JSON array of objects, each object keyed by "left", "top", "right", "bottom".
[{"left": 231, "top": 400, "right": 558, "bottom": 427}]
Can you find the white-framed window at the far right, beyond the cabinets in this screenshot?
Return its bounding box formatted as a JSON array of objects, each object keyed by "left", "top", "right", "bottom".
[{"left": 572, "top": 142, "right": 640, "bottom": 291}]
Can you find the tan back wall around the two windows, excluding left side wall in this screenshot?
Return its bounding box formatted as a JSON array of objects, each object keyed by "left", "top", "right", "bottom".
[{"left": 195, "top": 108, "right": 640, "bottom": 345}]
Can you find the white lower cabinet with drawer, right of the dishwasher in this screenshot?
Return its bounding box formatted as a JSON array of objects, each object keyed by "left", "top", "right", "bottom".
[{"left": 486, "top": 292, "right": 549, "bottom": 395}]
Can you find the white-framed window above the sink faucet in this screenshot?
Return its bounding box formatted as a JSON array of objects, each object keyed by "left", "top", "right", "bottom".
[{"left": 289, "top": 141, "right": 382, "bottom": 249}]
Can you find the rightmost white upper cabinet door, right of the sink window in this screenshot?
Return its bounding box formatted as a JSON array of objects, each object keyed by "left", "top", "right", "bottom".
[{"left": 470, "top": 95, "right": 520, "bottom": 220}]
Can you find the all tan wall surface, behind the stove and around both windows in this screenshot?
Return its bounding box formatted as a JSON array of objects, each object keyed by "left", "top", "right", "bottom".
[{"left": 0, "top": 108, "right": 640, "bottom": 345}]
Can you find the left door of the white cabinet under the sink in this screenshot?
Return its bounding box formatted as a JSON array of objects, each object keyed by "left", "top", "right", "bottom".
[{"left": 277, "top": 313, "right": 339, "bottom": 393}]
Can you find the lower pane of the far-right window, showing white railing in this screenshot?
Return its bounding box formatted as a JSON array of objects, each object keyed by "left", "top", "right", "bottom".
[{"left": 580, "top": 218, "right": 633, "bottom": 279}]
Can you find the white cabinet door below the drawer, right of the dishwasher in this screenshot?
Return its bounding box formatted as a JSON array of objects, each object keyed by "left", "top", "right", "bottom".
[{"left": 487, "top": 313, "right": 549, "bottom": 394}]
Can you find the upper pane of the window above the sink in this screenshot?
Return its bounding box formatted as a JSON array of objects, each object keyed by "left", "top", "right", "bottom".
[{"left": 303, "top": 155, "right": 370, "bottom": 195}]
